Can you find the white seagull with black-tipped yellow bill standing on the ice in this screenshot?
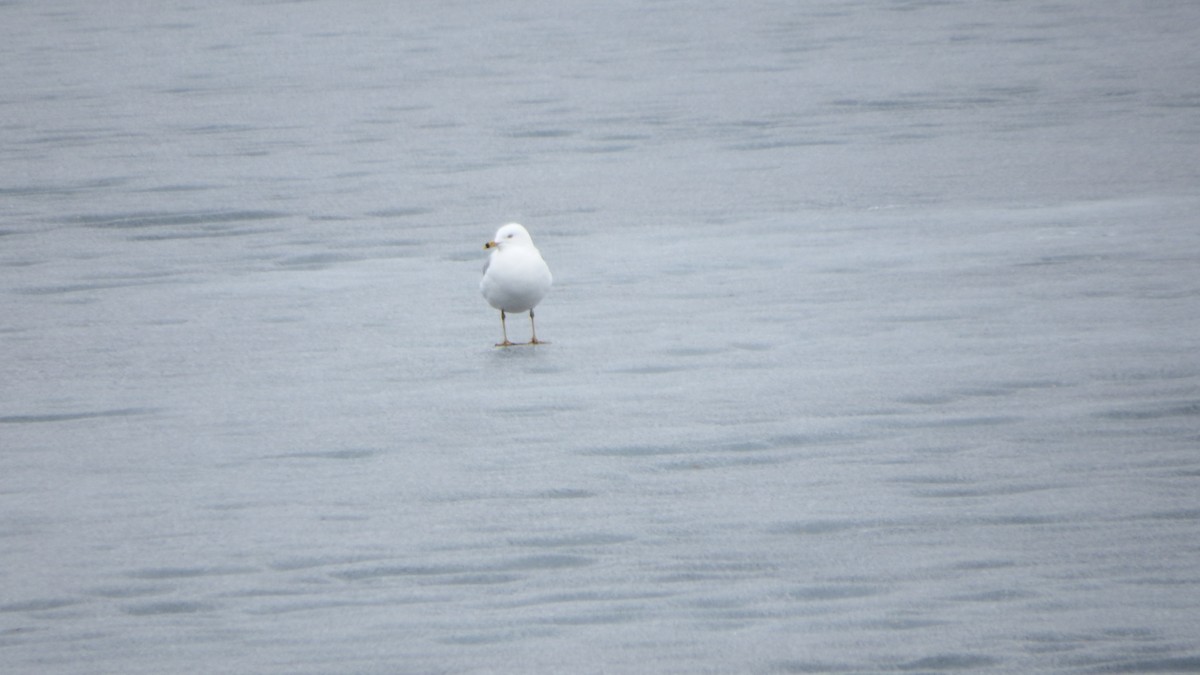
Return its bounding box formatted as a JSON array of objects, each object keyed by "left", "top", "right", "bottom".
[{"left": 479, "top": 222, "right": 554, "bottom": 347}]
